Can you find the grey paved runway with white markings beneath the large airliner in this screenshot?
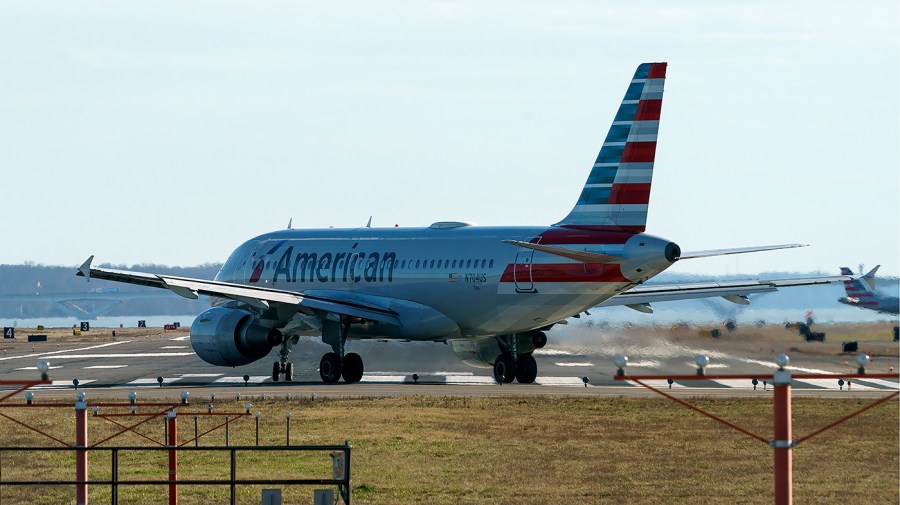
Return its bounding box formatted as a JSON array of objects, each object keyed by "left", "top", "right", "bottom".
[{"left": 0, "top": 324, "right": 898, "bottom": 397}]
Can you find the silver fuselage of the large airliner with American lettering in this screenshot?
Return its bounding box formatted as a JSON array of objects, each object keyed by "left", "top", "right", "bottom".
[{"left": 216, "top": 223, "right": 671, "bottom": 340}]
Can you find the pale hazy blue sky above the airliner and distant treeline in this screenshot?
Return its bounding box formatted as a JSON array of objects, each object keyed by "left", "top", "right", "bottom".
[{"left": 0, "top": 0, "right": 900, "bottom": 276}]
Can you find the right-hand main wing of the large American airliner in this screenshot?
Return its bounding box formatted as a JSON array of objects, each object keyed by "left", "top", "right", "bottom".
[{"left": 599, "top": 275, "right": 859, "bottom": 313}]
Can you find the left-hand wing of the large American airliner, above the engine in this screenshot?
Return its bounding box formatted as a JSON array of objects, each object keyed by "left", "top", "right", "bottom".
[{"left": 76, "top": 256, "right": 400, "bottom": 326}]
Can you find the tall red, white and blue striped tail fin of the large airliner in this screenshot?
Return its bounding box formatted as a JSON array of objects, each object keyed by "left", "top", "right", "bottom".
[{"left": 554, "top": 63, "right": 666, "bottom": 233}]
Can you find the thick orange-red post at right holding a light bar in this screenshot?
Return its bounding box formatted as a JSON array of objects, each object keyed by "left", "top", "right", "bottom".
[{"left": 772, "top": 368, "right": 794, "bottom": 505}]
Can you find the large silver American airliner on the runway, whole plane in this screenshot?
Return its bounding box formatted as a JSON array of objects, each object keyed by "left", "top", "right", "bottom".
[{"left": 76, "top": 63, "right": 851, "bottom": 384}]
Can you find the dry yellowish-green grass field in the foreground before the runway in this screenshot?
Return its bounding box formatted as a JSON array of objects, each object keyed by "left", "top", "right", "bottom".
[{"left": 0, "top": 397, "right": 900, "bottom": 504}]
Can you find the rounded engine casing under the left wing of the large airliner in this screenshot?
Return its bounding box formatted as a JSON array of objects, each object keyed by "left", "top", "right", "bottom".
[{"left": 191, "top": 307, "right": 282, "bottom": 366}]
